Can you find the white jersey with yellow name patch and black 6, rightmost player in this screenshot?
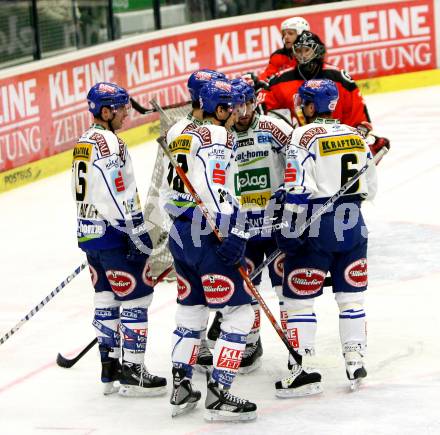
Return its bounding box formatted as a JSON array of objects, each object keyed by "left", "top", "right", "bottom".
[{"left": 284, "top": 118, "right": 377, "bottom": 200}]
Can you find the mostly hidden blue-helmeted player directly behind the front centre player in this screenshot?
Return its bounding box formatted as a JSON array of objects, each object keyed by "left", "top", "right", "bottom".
[{"left": 161, "top": 69, "right": 227, "bottom": 371}]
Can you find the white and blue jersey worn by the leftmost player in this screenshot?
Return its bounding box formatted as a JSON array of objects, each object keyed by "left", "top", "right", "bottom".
[{"left": 72, "top": 124, "right": 141, "bottom": 249}]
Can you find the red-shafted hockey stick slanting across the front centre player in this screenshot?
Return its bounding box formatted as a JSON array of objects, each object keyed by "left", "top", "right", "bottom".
[{"left": 151, "top": 100, "right": 302, "bottom": 365}]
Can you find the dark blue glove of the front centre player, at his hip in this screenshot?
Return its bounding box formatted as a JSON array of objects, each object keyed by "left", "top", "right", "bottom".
[{"left": 217, "top": 211, "right": 249, "bottom": 266}]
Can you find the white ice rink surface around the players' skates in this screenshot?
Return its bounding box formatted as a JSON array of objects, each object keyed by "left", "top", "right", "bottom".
[{"left": 0, "top": 87, "right": 440, "bottom": 435}]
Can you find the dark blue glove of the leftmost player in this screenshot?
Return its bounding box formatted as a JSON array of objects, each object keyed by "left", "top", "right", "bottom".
[{"left": 126, "top": 213, "right": 153, "bottom": 263}]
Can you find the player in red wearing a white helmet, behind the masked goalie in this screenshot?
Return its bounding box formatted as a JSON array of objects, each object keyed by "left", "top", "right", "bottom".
[{"left": 258, "top": 17, "right": 310, "bottom": 82}]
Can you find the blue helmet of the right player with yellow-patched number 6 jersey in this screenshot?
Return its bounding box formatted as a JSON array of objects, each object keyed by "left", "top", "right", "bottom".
[{"left": 298, "top": 79, "right": 339, "bottom": 113}]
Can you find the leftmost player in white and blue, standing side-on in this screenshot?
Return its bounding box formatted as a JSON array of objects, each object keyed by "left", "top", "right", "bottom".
[{"left": 72, "top": 82, "right": 166, "bottom": 396}]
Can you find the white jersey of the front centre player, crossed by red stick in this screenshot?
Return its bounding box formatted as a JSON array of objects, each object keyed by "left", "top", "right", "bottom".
[{"left": 160, "top": 120, "right": 239, "bottom": 225}]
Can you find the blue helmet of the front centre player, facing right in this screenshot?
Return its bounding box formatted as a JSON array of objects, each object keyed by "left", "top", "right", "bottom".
[{"left": 200, "top": 80, "right": 246, "bottom": 113}]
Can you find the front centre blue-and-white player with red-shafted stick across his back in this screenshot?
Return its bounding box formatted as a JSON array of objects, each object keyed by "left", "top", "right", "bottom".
[{"left": 162, "top": 81, "right": 256, "bottom": 421}]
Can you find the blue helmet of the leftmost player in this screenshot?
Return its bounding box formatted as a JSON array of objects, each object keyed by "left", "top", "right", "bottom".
[{"left": 87, "top": 82, "right": 130, "bottom": 117}]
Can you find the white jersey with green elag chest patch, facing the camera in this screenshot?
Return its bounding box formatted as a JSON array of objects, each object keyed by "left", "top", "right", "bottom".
[{"left": 233, "top": 113, "right": 293, "bottom": 237}]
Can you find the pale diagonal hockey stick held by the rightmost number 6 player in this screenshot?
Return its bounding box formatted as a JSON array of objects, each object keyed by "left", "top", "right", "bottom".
[{"left": 250, "top": 147, "right": 388, "bottom": 279}]
